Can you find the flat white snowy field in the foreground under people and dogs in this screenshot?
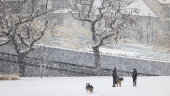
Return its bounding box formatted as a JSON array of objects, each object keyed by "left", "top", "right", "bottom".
[{"left": 0, "top": 76, "right": 170, "bottom": 96}]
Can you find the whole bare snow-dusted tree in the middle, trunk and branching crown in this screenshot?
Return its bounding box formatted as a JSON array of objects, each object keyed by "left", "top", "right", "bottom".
[{"left": 68, "top": 0, "right": 138, "bottom": 75}]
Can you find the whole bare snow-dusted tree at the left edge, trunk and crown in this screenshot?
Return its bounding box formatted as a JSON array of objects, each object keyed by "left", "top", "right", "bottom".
[{"left": 0, "top": 0, "right": 48, "bottom": 77}]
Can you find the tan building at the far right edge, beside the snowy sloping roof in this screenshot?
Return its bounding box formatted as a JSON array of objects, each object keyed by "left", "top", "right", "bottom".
[{"left": 144, "top": 0, "right": 170, "bottom": 35}]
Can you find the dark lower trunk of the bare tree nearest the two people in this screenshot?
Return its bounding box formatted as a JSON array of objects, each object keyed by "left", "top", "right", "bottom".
[{"left": 93, "top": 47, "right": 101, "bottom": 76}]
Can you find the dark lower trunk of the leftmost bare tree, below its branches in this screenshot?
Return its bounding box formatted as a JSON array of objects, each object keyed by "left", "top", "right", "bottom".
[{"left": 18, "top": 55, "right": 25, "bottom": 77}]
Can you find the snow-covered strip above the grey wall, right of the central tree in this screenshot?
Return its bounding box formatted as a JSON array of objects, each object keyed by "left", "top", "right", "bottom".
[{"left": 85, "top": 43, "right": 170, "bottom": 62}]
